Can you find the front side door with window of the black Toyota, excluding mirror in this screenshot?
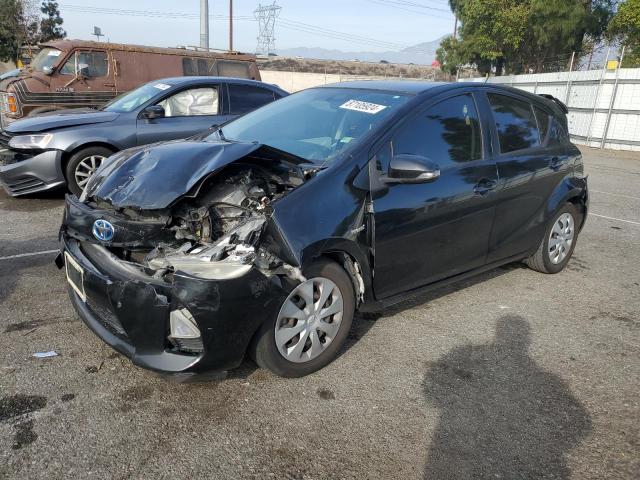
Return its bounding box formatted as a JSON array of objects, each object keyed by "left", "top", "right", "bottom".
[{"left": 374, "top": 93, "right": 497, "bottom": 298}]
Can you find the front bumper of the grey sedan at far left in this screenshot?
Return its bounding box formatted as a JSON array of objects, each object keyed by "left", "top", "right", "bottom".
[{"left": 0, "top": 149, "right": 66, "bottom": 197}]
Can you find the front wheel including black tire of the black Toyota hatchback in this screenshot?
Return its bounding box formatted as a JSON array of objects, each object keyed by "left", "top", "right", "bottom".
[{"left": 250, "top": 260, "right": 355, "bottom": 377}]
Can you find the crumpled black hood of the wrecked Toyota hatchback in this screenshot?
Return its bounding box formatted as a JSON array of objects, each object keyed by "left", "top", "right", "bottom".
[{"left": 83, "top": 140, "right": 303, "bottom": 210}]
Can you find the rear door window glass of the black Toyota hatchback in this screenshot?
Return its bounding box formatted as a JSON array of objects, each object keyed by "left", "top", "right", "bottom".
[{"left": 488, "top": 93, "right": 540, "bottom": 153}]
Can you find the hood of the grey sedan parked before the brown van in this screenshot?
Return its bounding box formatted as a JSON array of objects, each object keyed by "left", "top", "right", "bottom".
[{"left": 6, "top": 109, "right": 119, "bottom": 133}]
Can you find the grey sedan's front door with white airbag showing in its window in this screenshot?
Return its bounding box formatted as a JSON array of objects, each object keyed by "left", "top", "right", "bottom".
[{"left": 137, "top": 82, "right": 228, "bottom": 145}]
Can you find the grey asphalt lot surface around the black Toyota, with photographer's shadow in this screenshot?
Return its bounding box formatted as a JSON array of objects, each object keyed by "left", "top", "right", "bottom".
[{"left": 0, "top": 150, "right": 640, "bottom": 480}]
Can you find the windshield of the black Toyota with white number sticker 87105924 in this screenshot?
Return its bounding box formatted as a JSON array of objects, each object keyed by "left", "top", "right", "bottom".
[{"left": 207, "top": 88, "right": 408, "bottom": 163}]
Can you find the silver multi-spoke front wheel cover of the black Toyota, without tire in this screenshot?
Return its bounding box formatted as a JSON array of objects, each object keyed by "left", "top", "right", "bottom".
[{"left": 275, "top": 277, "right": 344, "bottom": 363}]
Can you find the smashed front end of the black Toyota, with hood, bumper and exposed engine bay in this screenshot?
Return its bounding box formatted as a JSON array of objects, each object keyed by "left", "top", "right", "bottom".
[{"left": 61, "top": 142, "right": 315, "bottom": 373}]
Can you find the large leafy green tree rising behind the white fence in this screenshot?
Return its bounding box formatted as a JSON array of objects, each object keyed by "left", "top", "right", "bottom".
[{"left": 442, "top": 0, "right": 616, "bottom": 75}]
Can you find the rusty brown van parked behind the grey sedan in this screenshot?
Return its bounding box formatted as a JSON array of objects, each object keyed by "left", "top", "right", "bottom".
[{"left": 0, "top": 40, "right": 260, "bottom": 126}]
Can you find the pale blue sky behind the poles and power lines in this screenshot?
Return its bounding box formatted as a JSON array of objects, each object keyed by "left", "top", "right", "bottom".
[{"left": 59, "top": 0, "right": 453, "bottom": 51}]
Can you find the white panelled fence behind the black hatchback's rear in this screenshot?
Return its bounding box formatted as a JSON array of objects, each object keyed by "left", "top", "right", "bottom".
[{"left": 470, "top": 68, "right": 640, "bottom": 151}]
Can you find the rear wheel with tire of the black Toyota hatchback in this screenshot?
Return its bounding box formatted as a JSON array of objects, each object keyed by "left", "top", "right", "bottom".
[{"left": 525, "top": 203, "right": 581, "bottom": 273}]
